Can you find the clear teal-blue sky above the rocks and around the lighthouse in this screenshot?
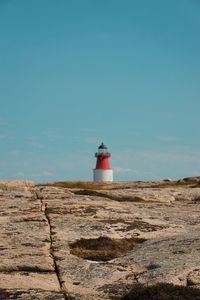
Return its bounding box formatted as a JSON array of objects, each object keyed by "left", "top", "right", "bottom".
[{"left": 0, "top": 0, "right": 200, "bottom": 182}]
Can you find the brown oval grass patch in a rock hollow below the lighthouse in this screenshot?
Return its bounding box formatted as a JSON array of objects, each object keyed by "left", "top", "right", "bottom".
[{"left": 69, "top": 236, "right": 145, "bottom": 261}]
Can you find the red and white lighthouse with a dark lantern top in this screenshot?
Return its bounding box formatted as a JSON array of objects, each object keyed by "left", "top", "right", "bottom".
[{"left": 93, "top": 143, "right": 113, "bottom": 182}]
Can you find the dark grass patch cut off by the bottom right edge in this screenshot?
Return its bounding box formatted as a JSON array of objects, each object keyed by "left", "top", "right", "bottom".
[{"left": 121, "top": 283, "right": 200, "bottom": 300}]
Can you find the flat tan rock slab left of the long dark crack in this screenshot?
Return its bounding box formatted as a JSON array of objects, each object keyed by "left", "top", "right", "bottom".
[{"left": 0, "top": 182, "right": 63, "bottom": 299}]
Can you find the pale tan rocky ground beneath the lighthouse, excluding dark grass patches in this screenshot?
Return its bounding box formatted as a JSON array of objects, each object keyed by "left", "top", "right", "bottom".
[{"left": 0, "top": 178, "right": 200, "bottom": 300}]
